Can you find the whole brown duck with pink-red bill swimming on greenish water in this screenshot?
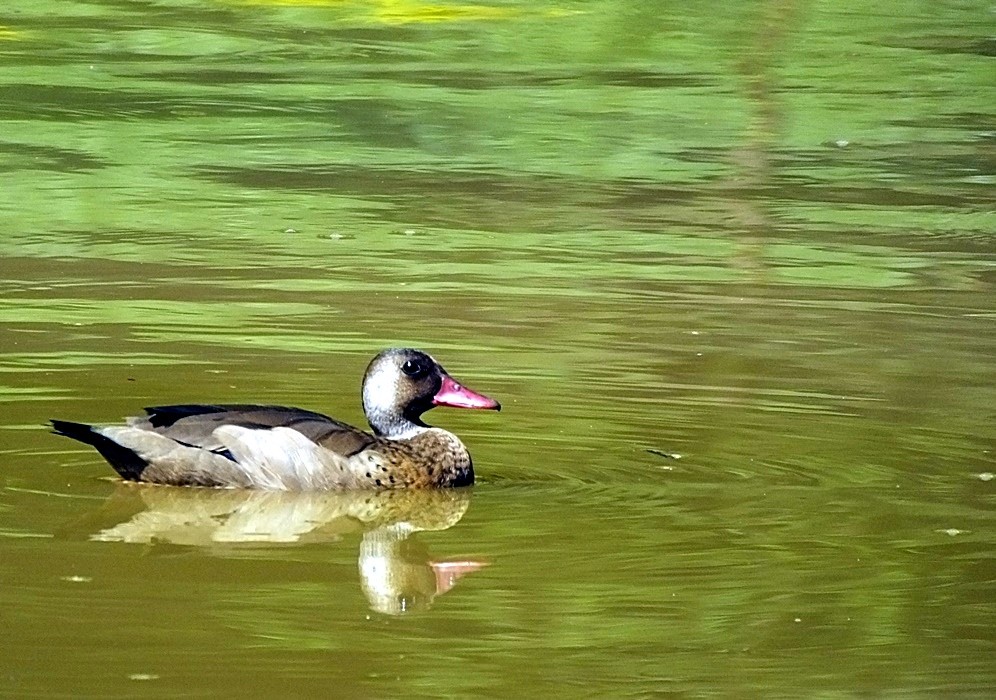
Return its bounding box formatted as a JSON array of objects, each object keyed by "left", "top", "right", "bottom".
[{"left": 50, "top": 348, "right": 501, "bottom": 491}]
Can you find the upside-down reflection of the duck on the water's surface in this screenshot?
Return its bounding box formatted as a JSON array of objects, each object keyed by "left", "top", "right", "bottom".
[{"left": 91, "top": 483, "right": 486, "bottom": 615}]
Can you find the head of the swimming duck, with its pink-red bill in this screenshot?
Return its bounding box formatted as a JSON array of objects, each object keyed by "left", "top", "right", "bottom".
[{"left": 363, "top": 348, "right": 501, "bottom": 439}]
